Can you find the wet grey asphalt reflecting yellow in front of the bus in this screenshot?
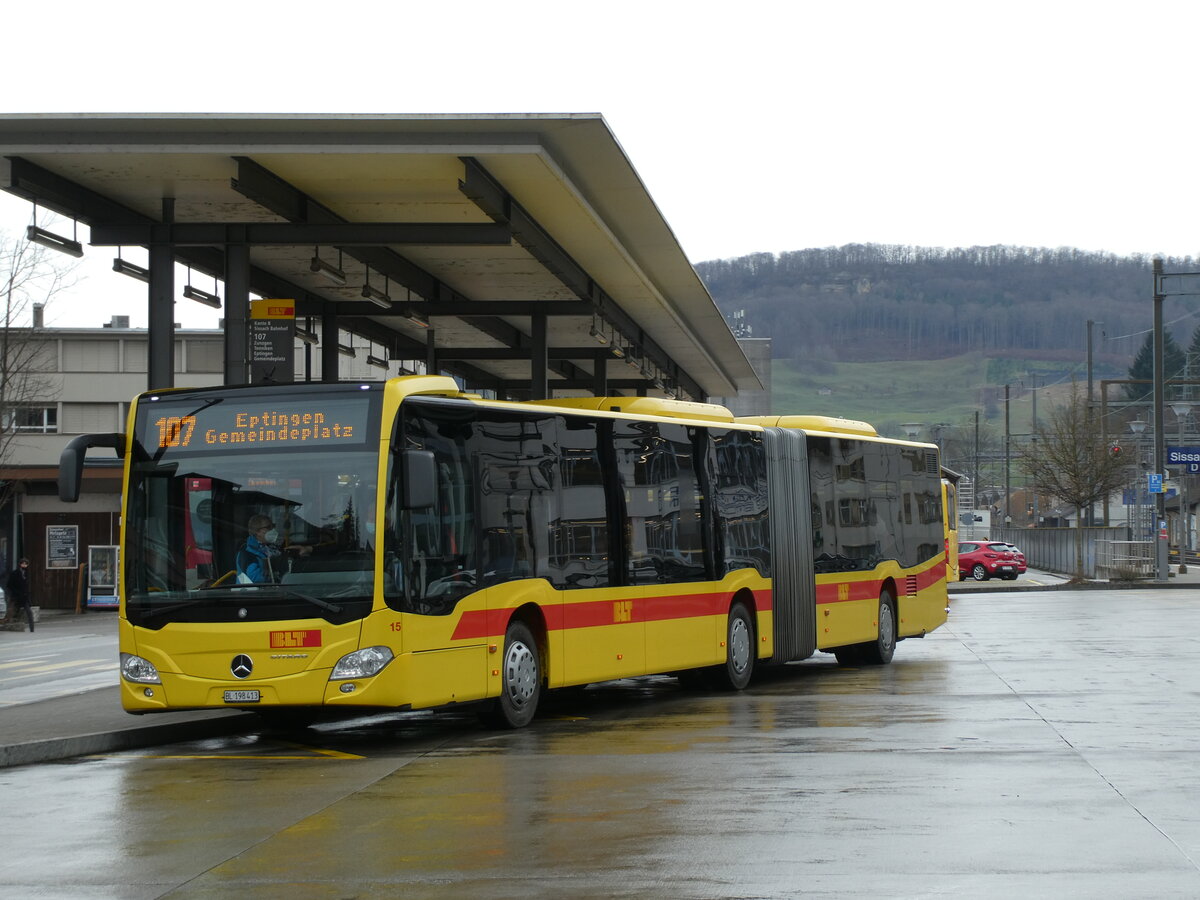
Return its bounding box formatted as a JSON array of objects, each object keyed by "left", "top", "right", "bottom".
[{"left": 0, "top": 587, "right": 1200, "bottom": 898}]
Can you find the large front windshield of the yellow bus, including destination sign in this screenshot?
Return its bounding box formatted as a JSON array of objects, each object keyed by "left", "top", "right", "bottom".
[{"left": 125, "top": 391, "right": 378, "bottom": 628}]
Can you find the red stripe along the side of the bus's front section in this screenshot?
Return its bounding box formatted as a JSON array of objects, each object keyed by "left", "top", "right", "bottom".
[{"left": 450, "top": 590, "right": 772, "bottom": 641}]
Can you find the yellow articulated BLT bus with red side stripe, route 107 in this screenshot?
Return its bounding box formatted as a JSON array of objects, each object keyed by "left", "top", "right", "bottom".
[{"left": 60, "top": 376, "right": 947, "bottom": 727}]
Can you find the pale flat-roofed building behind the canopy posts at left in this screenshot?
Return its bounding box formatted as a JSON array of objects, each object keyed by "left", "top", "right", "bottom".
[{"left": 0, "top": 308, "right": 393, "bottom": 610}]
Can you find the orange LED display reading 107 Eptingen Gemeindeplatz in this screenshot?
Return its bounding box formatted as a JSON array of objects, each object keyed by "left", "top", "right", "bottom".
[{"left": 138, "top": 396, "right": 371, "bottom": 455}]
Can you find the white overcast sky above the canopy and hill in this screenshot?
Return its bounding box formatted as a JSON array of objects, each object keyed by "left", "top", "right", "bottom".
[{"left": 0, "top": 0, "right": 1200, "bottom": 326}]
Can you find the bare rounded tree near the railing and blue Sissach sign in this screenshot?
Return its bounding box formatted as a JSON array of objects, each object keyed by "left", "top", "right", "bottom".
[{"left": 1018, "top": 385, "right": 1126, "bottom": 580}]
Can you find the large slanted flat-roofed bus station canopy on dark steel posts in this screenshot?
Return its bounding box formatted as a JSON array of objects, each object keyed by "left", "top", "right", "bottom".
[{"left": 0, "top": 114, "right": 761, "bottom": 400}]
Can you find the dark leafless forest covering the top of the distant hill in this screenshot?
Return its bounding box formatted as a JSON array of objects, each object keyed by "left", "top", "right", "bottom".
[{"left": 696, "top": 244, "right": 1200, "bottom": 362}]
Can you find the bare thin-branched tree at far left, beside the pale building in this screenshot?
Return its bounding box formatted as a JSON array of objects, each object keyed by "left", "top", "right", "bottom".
[{"left": 0, "top": 226, "right": 76, "bottom": 505}]
